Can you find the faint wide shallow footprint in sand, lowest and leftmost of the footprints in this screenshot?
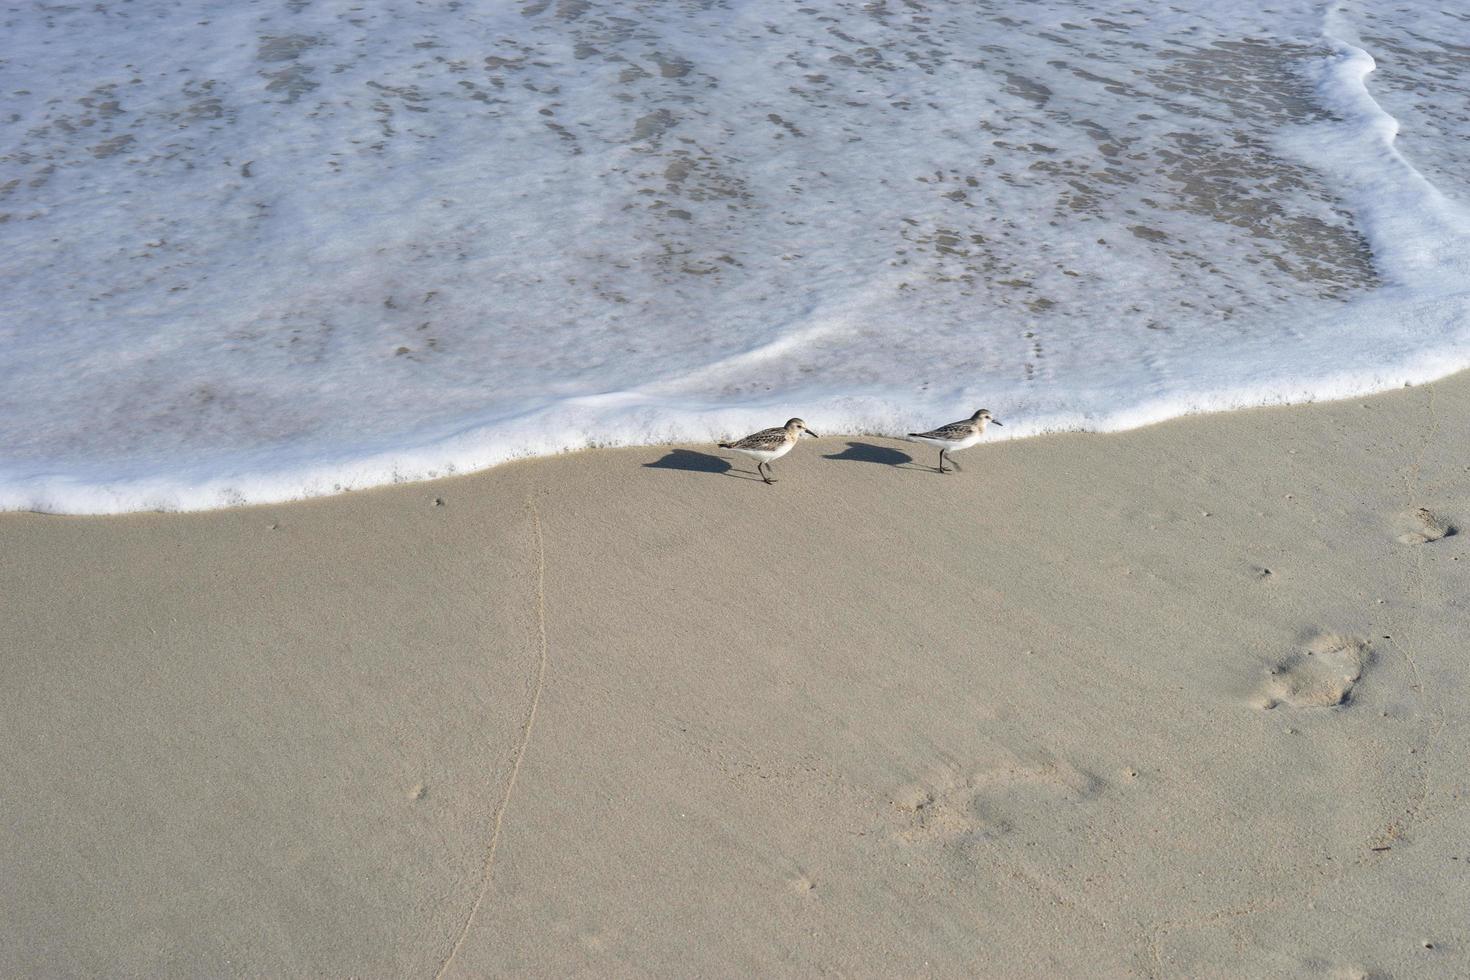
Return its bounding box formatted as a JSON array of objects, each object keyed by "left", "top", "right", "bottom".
[{"left": 891, "top": 760, "right": 1104, "bottom": 842}]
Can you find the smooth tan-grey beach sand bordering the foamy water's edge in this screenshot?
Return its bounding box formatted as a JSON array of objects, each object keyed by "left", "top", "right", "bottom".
[{"left": 0, "top": 376, "right": 1470, "bottom": 977}]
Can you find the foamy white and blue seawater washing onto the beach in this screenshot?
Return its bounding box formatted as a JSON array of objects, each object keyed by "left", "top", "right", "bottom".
[{"left": 0, "top": 0, "right": 1470, "bottom": 513}]
